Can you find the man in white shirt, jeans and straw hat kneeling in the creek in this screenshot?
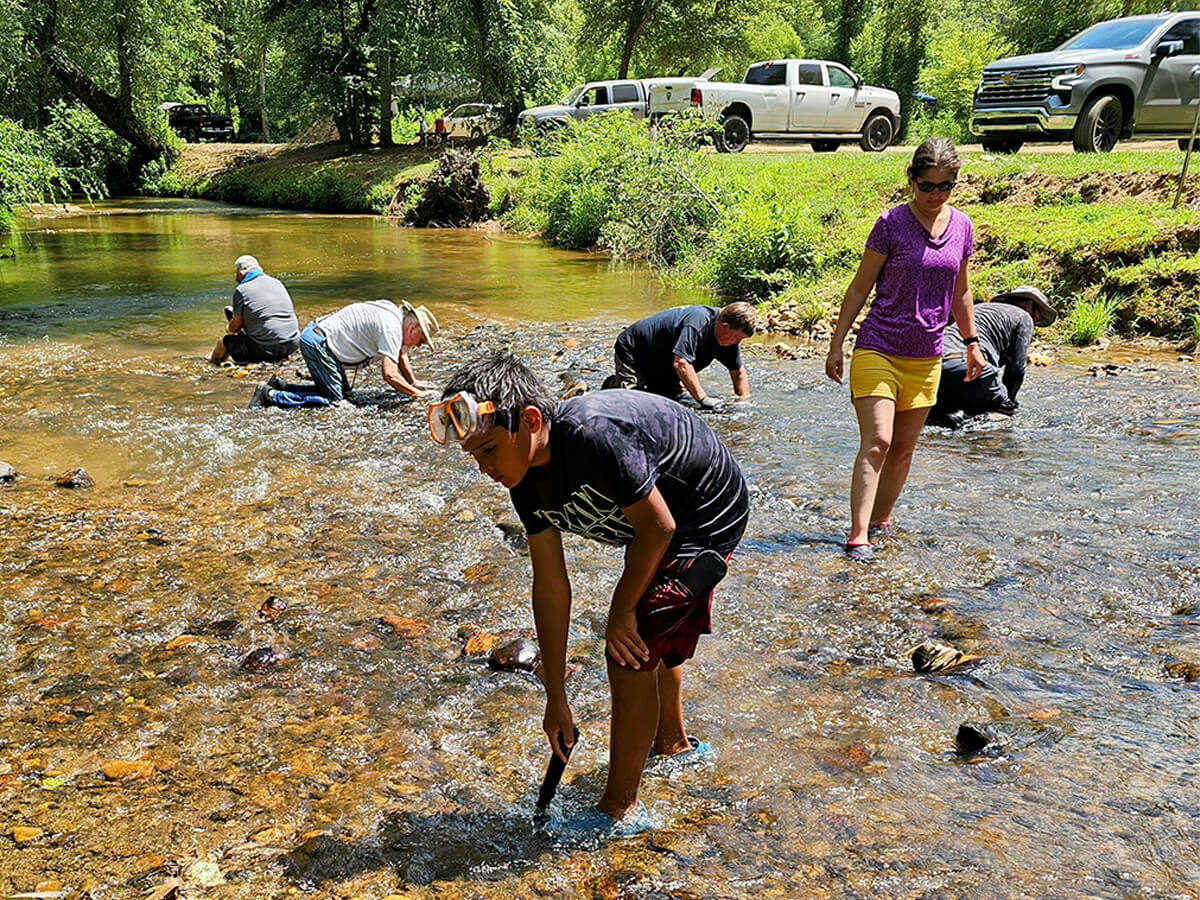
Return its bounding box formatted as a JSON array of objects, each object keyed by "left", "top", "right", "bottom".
[{"left": 251, "top": 300, "right": 438, "bottom": 408}]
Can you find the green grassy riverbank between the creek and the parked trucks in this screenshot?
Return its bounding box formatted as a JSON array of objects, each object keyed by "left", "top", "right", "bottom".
[{"left": 149, "top": 137, "right": 1200, "bottom": 349}]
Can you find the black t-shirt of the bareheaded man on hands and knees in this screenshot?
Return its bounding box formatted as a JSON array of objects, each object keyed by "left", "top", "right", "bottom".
[{"left": 617, "top": 306, "right": 742, "bottom": 396}]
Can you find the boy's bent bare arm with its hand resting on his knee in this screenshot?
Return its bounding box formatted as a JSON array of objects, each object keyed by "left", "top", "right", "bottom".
[{"left": 605, "top": 487, "right": 674, "bottom": 667}]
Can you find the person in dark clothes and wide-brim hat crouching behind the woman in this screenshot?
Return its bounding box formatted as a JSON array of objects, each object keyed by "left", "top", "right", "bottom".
[{"left": 928, "top": 284, "right": 1058, "bottom": 428}]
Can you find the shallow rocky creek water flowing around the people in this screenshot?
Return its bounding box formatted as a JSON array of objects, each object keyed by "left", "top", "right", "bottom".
[{"left": 0, "top": 202, "right": 1200, "bottom": 899}]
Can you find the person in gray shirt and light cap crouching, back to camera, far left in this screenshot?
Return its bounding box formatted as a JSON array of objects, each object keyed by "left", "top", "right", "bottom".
[{"left": 209, "top": 256, "right": 300, "bottom": 365}]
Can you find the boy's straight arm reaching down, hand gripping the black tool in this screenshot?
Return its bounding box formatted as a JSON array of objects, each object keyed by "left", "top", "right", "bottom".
[{"left": 528, "top": 528, "right": 575, "bottom": 762}]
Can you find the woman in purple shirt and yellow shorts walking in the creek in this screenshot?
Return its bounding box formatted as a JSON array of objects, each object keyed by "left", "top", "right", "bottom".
[{"left": 826, "top": 138, "right": 984, "bottom": 562}]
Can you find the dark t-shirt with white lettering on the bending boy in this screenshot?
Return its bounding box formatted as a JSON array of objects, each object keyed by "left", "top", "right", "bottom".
[{"left": 510, "top": 390, "right": 750, "bottom": 558}]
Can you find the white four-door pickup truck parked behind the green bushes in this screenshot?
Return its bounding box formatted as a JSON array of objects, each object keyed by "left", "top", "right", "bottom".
[{"left": 676, "top": 59, "right": 900, "bottom": 154}]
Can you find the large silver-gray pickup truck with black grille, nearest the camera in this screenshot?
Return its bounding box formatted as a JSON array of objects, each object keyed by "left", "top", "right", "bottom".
[{"left": 971, "top": 11, "right": 1200, "bottom": 154}]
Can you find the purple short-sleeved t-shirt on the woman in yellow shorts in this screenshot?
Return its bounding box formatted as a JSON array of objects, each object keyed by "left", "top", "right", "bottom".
[{"left": 854, "top": 203, "right": 974, "bottom": 359}]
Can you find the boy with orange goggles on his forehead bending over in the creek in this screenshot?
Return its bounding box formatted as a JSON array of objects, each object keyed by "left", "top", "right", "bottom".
[{"left": 430, "top": 353, "right": 750, "bottom": 836}]
